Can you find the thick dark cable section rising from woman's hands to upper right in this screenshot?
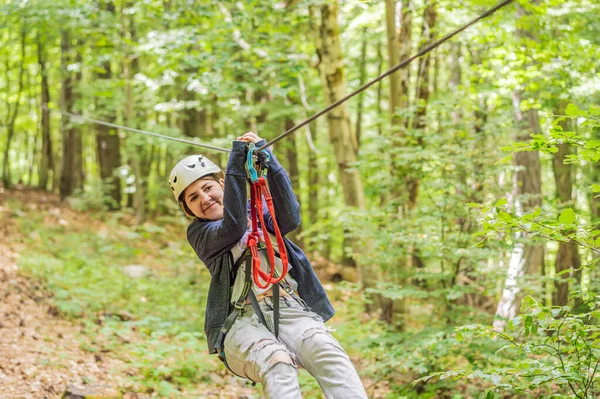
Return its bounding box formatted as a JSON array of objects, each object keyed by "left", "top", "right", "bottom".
[{"left": 258, "top": 0, "right": 513, "bottom": 151}]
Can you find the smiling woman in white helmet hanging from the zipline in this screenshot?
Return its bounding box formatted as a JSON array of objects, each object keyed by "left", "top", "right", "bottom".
[{"left": 169, "top": 132, "right": 367, "bottom": 399}]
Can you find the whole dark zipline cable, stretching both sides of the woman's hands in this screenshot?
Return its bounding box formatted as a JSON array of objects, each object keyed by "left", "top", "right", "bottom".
[{"left": 42, "top": 0, "right": 513, "bottom": 152}]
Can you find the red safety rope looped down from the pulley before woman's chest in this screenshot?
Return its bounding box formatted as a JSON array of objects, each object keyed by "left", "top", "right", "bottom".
[{"left": 247, "top": 176, "right": 288, "bottom": 288}]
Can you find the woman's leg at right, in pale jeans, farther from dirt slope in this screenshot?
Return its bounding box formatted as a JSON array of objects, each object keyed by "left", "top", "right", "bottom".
[{"left": 265, "top": 298, "right": 367, "bottom": 399}]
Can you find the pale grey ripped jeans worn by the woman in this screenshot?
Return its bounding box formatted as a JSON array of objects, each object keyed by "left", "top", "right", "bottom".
[{"left": 224, "top": 297, "right": 367, "bottom": 399}]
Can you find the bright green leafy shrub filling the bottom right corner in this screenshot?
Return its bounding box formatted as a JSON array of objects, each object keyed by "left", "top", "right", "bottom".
[{"left": 417, "top": 296, "right": 600, "bottom": 399}]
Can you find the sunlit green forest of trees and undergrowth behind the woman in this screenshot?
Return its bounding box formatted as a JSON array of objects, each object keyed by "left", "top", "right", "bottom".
[{"left": 0, "top": 0, "right": 600, "bottom": 398}]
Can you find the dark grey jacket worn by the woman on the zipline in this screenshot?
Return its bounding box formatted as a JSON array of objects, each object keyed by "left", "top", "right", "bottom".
[{"left": 187, "top": 141, "right": 334, "bottom": 353}]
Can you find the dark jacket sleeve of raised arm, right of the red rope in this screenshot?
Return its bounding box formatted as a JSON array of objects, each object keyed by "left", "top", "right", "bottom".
[{"left": 256, "top": 141, "right": 301, "bottom": 235}]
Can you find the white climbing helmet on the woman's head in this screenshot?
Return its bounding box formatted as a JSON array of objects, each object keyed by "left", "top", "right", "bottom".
[{"left": 169, "top": 155, "right": 225, "bottom": 201}]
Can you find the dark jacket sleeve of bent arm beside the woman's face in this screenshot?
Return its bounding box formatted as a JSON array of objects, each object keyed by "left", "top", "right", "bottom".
[{"left": 187, "top": 141, "right": 248, "bottom": 274}]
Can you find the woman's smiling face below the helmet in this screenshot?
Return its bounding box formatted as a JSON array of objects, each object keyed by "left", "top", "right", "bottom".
[{"left": 183, "top": 176, "right": 224, "bottom": 220}]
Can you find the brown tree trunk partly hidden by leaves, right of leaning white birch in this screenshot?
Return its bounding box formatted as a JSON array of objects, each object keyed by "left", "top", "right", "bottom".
[{"left": 552, "top": 101, "right": 581, "bottom": 306}]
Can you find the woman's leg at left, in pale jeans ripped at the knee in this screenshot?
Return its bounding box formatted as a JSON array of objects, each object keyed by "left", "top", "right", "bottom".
[{"left": 224, "top": 309, "right": 302, "bottom": 399}]
